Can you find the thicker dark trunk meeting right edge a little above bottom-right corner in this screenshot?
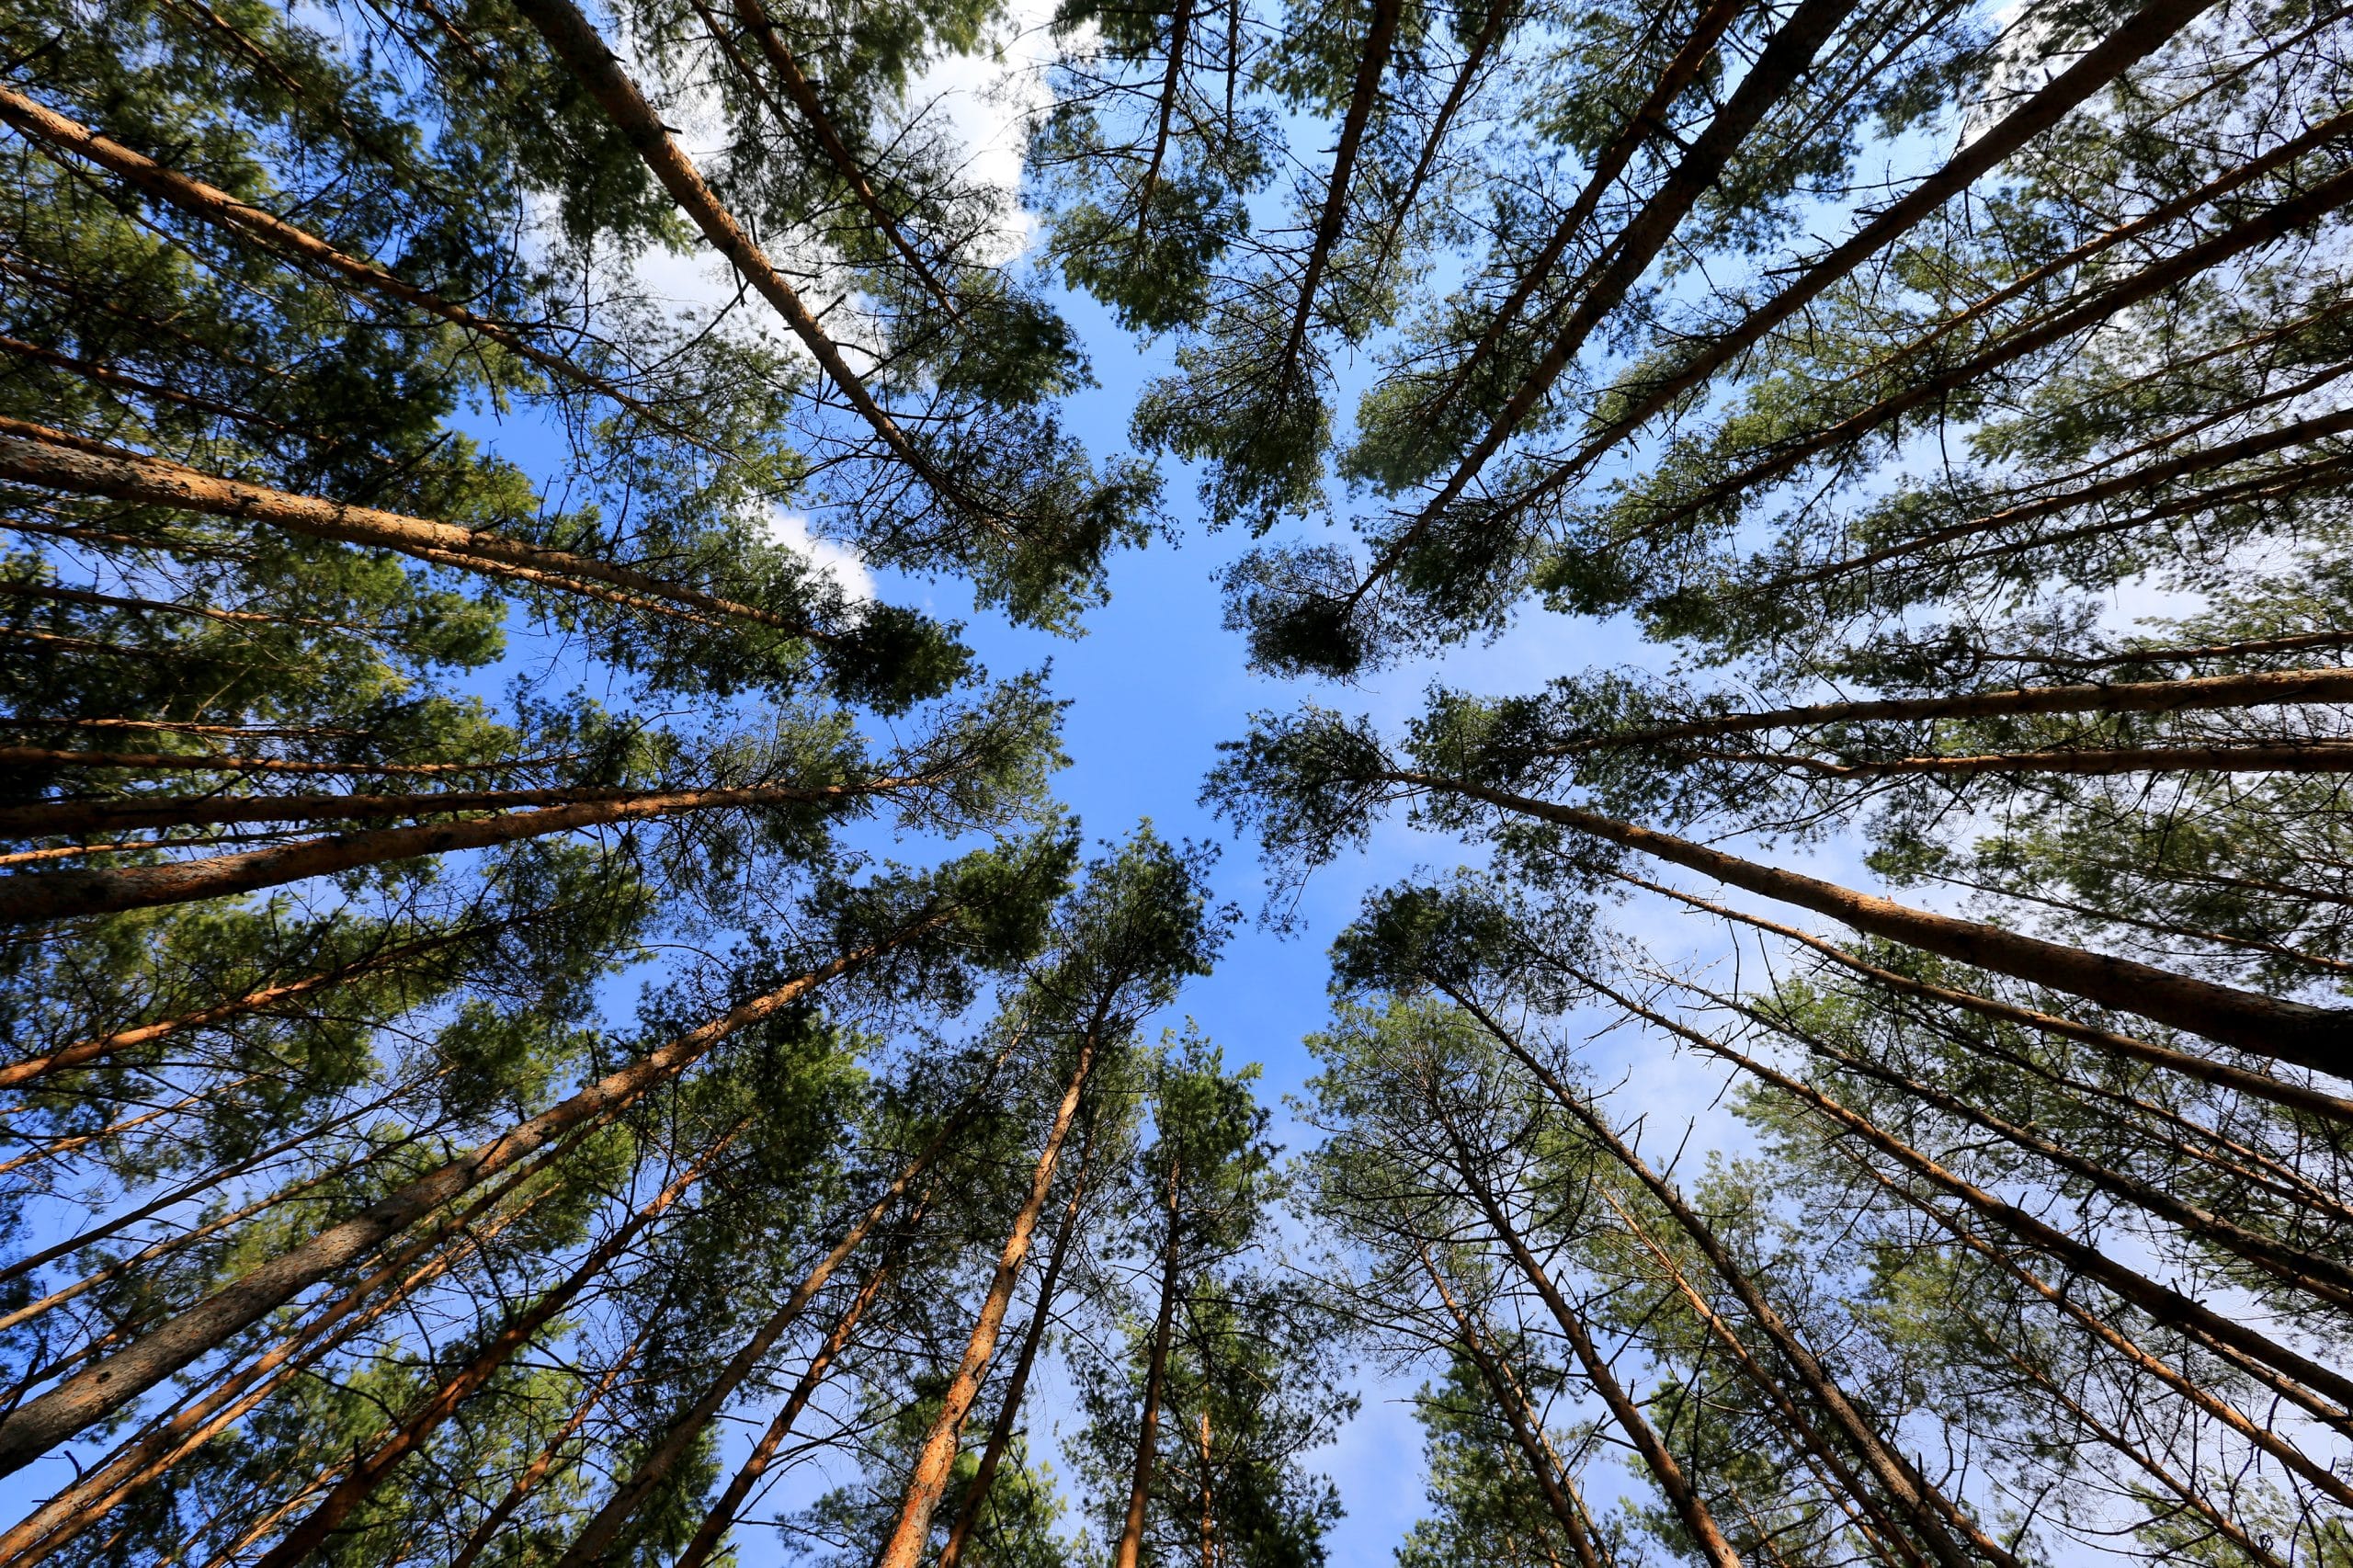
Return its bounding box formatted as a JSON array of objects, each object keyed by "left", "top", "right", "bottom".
[{"left": 1579, "top": 974, "right": 2353, "bottom": 1431}]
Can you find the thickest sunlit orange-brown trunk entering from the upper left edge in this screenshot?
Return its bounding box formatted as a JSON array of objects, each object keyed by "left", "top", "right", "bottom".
[{"left": 0, "top": 421, "right": 826, "bottom": 642}]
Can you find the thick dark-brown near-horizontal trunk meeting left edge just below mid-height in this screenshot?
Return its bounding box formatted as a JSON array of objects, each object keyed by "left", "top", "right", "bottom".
[{"left": 0, "top": 779, "right": 911, "bottom": 926}]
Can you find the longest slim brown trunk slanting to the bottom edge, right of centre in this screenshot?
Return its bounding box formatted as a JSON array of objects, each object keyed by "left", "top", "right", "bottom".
[{"left": 1447, "top": 986, "right": 2017, "bottom": 1568}]
